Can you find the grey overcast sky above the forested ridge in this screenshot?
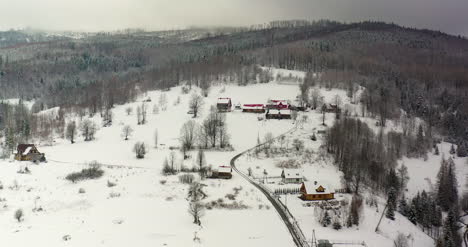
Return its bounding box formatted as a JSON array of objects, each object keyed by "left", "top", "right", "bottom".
[{"left": 0, "top": 0, "right": 468, "bottom": 36}]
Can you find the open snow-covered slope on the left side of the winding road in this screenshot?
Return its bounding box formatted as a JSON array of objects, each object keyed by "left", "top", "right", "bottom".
[{"left": 0, "top": 78, "right": 304, "bottom": 246}]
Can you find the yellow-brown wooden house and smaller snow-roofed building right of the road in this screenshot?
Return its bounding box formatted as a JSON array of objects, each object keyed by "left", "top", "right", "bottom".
[{"left": 281, "top": 169, "right": 335, "bottom": 201}]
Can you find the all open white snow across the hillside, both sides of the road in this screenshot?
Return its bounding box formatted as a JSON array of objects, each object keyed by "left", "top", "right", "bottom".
[{"left": 0, "top": 68, "right": 462, "bottom": 247}]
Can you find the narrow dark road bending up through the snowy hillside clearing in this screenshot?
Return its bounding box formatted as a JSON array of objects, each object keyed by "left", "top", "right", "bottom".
[{"left": 231, "top": 128, "right": 309, "bottom": 247}]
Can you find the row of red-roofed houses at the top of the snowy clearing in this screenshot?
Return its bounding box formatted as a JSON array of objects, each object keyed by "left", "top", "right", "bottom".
[{"left": 216, "top": 98, "right": 295, "bottom": 119}]
